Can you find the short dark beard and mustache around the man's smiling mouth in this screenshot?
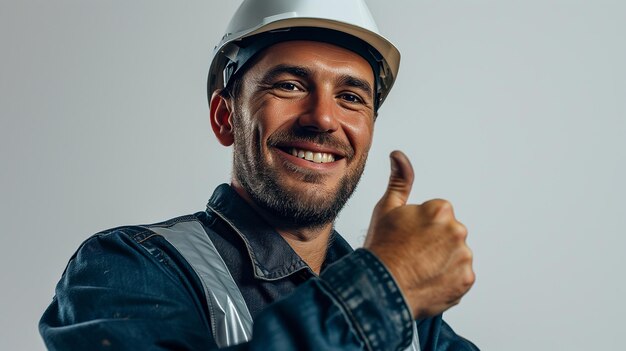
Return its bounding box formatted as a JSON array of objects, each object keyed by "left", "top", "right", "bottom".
[{"left": 232, "top": 107, "right": 367, "bottom": 228}]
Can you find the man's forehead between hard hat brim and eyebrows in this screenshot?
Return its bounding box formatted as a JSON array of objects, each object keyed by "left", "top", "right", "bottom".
[{"left": 244, "top": 40, "right": 374, "bottom": 84}]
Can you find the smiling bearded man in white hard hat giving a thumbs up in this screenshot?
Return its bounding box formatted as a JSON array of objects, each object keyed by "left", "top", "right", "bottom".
[{"left": 40, "top": 0, "right": 476, "bottom": 350}]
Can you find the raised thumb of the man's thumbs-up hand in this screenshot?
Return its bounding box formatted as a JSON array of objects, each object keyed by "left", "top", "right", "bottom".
[{"left": 378, "top": 150, "right": 415, "bottom": 214}]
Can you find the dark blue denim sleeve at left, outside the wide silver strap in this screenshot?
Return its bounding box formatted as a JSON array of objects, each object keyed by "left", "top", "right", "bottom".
[{"left": 39, "top": 231, "right": 214, "bottom": 350}]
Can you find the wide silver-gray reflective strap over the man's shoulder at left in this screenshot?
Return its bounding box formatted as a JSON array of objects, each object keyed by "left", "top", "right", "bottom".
[{"left": 145, "top": 220, "right": 252, "bottom": 348}]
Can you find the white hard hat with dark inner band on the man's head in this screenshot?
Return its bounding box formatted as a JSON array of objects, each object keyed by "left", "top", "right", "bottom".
[{"left": 207, "top": 0, "right": 400, "bottom": 107}]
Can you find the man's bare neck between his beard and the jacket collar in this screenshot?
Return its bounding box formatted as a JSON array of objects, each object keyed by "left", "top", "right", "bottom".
[{"left": 231, "top": 180, "right": 333, "bottom": 274}]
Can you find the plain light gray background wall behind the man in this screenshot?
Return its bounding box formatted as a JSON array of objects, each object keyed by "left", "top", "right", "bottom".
[{"left": 0, "top": 0, "right": 626, "bottom": 351}]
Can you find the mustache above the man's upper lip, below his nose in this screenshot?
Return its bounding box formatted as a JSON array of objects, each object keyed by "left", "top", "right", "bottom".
[{"left": 267, "top": 128, "right": 354, "bottom": 160}]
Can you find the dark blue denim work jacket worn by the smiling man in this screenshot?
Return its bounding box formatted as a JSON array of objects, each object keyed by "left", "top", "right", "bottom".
[{"left": 39, "top": 184, "right": 477, "bottom": 351}]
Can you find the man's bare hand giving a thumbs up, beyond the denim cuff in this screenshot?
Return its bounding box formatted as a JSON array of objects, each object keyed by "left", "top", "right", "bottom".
[{"left": 364, "top": 151, "right": 475, "bottom": 319}]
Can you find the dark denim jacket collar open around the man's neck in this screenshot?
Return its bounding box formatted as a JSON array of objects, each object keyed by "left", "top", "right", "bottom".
[{"left": 207, "top": 184, "right": 352, "bottom": 280}]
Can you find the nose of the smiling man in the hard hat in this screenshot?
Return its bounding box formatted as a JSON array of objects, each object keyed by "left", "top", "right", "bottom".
[{"left": 298, "top": 92, "right": 339, "bottom": 133}]
